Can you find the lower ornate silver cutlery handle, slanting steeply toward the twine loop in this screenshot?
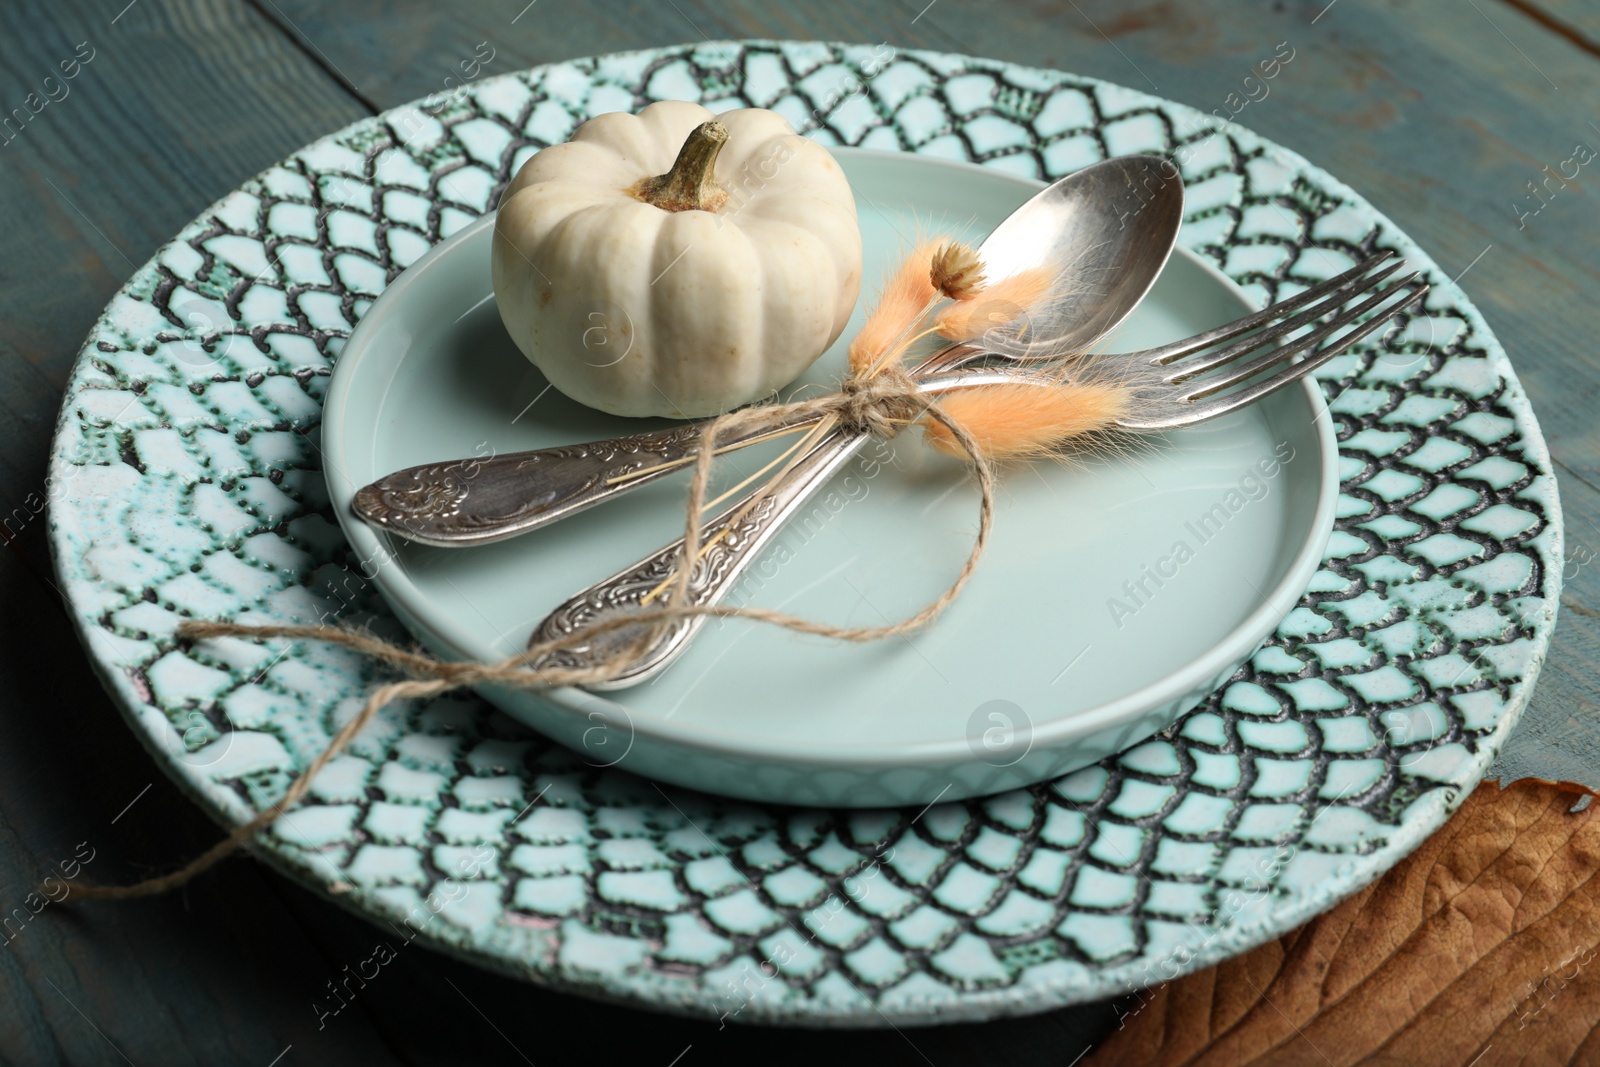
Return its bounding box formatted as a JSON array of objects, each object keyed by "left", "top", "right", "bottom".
[{"left": 528, "top": 370, "right": 1056, "bottom": 689}]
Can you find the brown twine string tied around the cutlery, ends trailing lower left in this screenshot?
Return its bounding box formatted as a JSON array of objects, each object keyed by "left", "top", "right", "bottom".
[{"left": 69, "top": 365, "right": 995, "bottom": 901}]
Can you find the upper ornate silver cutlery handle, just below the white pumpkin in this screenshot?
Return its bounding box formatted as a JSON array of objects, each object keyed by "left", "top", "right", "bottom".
[{"left": 354, "top": 404, "right": 811, "bottom": 547}]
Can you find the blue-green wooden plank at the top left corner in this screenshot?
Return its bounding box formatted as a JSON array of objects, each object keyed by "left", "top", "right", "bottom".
[{"left": 0, "top": 0, "right": 368, "bottom": 389}]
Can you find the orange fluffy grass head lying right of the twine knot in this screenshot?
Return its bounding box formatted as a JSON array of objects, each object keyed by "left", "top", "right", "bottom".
[{"left": 922, "top": 381, "right": 1136, "bottom": 461}]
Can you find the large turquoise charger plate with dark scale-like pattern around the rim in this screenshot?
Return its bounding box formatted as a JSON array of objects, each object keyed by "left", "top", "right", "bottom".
[{"left": 50, "top": 42, "right": 1562, "bottom": 1025}]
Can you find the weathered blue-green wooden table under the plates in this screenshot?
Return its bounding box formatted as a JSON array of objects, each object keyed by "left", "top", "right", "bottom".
[{"left": 0, "top": 0, "right": 1600, "bottom": 1067}]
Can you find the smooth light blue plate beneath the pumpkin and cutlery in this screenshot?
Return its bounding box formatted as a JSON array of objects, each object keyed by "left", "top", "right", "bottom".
[{"left": 323, "top": 149, "right": 1338, "bottom": 808}]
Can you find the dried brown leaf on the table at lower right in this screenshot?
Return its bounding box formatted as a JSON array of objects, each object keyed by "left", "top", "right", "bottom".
[{"left": 1083, "top": 779, "right": 1600, "bottom": 1067}]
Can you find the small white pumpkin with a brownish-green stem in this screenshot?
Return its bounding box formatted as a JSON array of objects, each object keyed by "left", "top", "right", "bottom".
[{"left": 493, "top": 101, "right": 861, "bottom": 419}]
